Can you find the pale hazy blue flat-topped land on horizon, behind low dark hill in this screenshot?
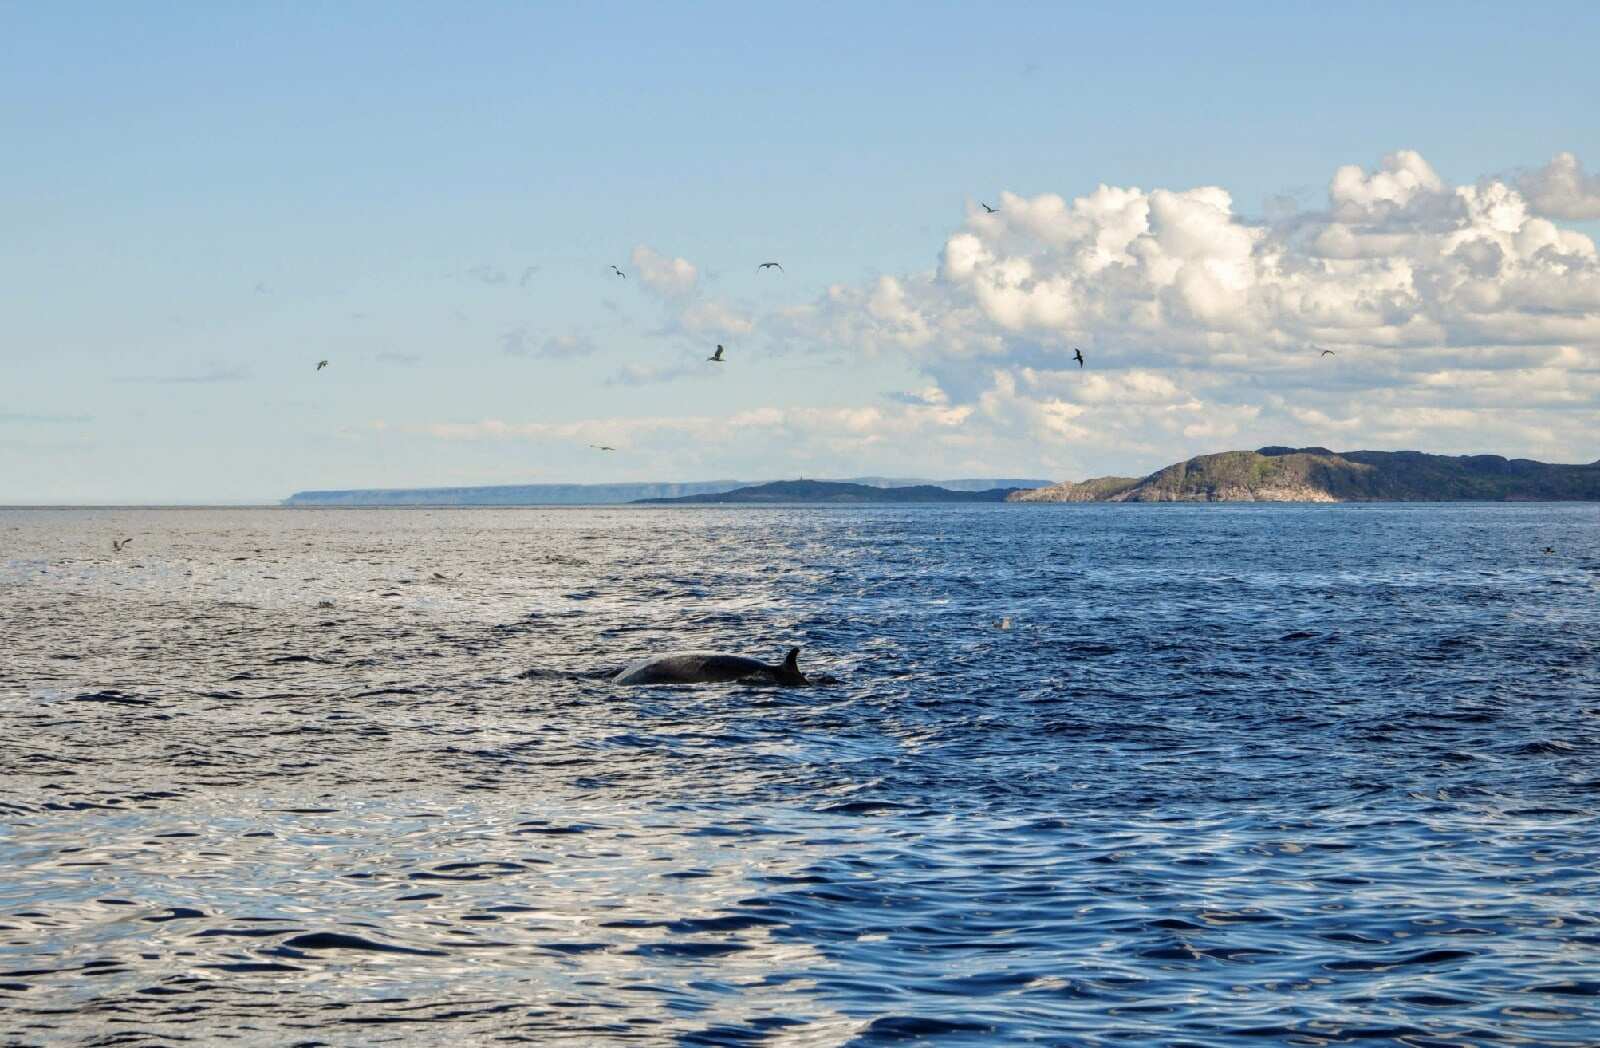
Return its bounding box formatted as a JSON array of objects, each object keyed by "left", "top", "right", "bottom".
[{"left": 283, "top": 477, "right": 1050, "bottom": 506}]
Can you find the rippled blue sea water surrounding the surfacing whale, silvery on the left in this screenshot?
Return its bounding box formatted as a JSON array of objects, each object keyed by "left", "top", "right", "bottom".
[{"left": 0, "top": 504, "right": 1600, "bottom": 1045}]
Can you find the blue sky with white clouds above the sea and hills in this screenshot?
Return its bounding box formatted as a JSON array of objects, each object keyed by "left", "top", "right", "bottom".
[{"left": 0, "top": 0, "right": 1600, "bottom": 504}]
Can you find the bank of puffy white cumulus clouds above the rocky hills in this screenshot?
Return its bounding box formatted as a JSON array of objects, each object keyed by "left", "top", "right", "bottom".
[{"left": 419, "top": 150, "right": 1600, "bottom": 477}]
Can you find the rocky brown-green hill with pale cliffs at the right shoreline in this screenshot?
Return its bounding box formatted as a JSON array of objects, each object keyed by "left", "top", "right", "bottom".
[{"left": 1011, "top": 446, "right": 1600, "bottom": 502}]
